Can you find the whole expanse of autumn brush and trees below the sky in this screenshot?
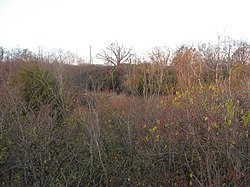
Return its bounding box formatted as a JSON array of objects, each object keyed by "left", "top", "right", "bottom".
[{"left": 0, "top": 39, "right": 250, "bottom": 186}]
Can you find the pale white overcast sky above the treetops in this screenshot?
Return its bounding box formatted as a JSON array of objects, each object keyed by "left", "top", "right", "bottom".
[{"left": 0, "top": 0, "right": 250, "bottom": 57}]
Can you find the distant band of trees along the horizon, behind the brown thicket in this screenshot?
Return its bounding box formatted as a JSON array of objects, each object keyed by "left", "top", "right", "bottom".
[{"left": 0, "top": 39, "right": 250, "bottom": 97}]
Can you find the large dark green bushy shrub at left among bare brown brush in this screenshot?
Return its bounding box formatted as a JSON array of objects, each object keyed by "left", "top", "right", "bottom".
[{"left": 13, "top": 61, "right": 65, "bottom": 119}]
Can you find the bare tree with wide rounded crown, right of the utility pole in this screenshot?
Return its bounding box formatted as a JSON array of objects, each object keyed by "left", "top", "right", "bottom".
[{"left": 97, "top": 41, "right": 134, "bottom": 65}]
